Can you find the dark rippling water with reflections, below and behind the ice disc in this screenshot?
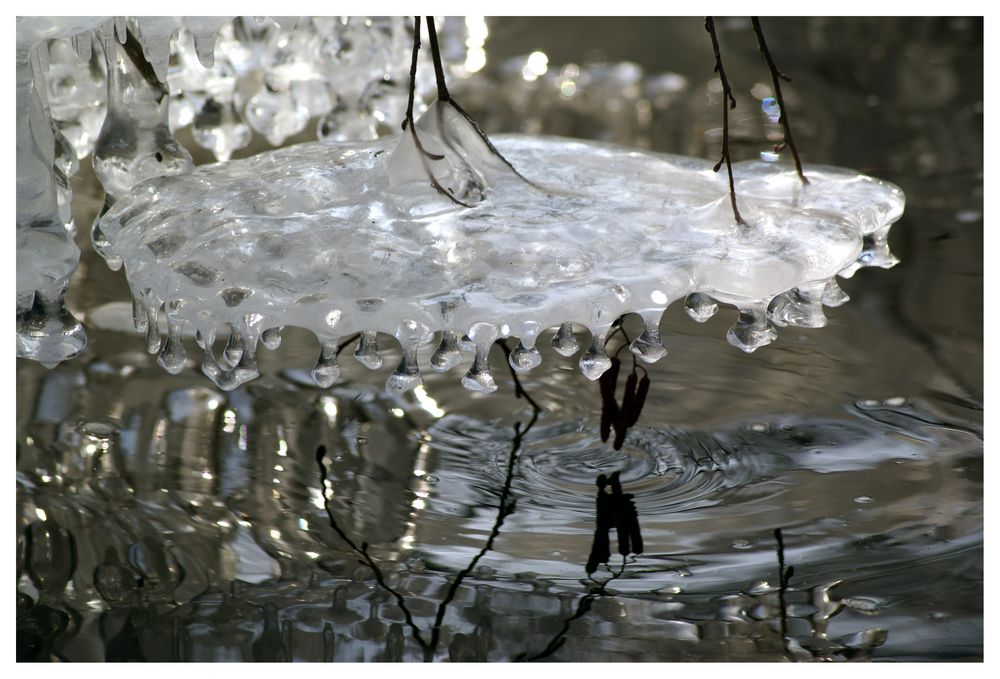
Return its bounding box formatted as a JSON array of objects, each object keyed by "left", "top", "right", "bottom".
[{"left": 17, "top": 18, "right": 983, "bottom": 661}]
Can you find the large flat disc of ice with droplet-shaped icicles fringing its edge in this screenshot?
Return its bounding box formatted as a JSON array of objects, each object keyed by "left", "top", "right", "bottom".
[{"left": 100, "top": 103, "right": 904, "bottom": 391}]
